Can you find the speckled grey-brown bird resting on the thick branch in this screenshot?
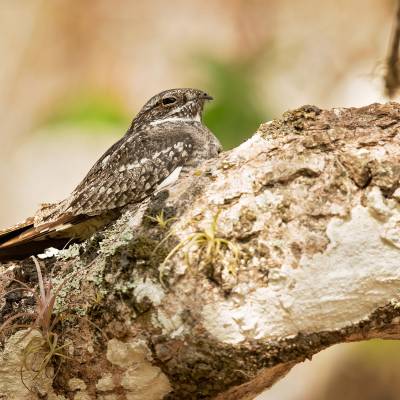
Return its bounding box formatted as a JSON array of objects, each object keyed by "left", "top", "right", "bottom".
[{"left": 0, "top": 88, "right": 222, "bottom": 262}]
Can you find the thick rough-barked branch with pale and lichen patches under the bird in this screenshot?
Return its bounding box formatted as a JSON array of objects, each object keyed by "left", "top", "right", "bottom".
[{"left": 0, "top": 103, "right": 400, "bottom": 400}]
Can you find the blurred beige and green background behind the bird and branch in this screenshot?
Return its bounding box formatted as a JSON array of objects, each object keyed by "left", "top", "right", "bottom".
[{"left": 0, "top": 0, "right": 400, "bottom": 400}]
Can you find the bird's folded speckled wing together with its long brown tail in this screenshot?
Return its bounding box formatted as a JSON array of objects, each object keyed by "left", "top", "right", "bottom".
[{"left": 0, "top": 126, "right": 193, "bottom": 260}]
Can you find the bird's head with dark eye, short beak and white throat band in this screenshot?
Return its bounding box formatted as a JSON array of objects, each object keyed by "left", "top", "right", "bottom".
[{"left": 133, "top": 89, "right": 212, "bottom": 126}]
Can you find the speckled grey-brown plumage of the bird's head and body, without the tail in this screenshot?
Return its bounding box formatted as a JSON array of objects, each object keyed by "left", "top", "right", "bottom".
[{"left": 57, "top": 89, "right": 221, "bottom": 219}]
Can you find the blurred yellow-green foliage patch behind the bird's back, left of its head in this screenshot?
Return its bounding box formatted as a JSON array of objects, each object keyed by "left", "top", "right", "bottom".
[{"left": 42, "top": 91, "right": 131, "bottom": 132}]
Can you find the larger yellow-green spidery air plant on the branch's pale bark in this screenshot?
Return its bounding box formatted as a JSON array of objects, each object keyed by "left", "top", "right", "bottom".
[{"left": 160, "top": 212, "right": 239, "bottom": 278}]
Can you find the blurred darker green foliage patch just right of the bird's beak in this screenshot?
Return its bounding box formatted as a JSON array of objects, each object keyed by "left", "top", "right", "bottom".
[{"left": 200, "top": 57, "right": 270, "bottom": 149}]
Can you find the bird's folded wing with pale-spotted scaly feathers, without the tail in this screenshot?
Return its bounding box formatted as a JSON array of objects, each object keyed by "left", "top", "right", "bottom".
[{"left": 65, "top": 124, "right": 195, "bottom": 215}]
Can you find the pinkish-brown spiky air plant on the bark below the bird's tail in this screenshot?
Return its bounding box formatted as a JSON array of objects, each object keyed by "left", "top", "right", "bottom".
[{"left": 0, "top": 257, "right": 69, "bottom": 390}]
